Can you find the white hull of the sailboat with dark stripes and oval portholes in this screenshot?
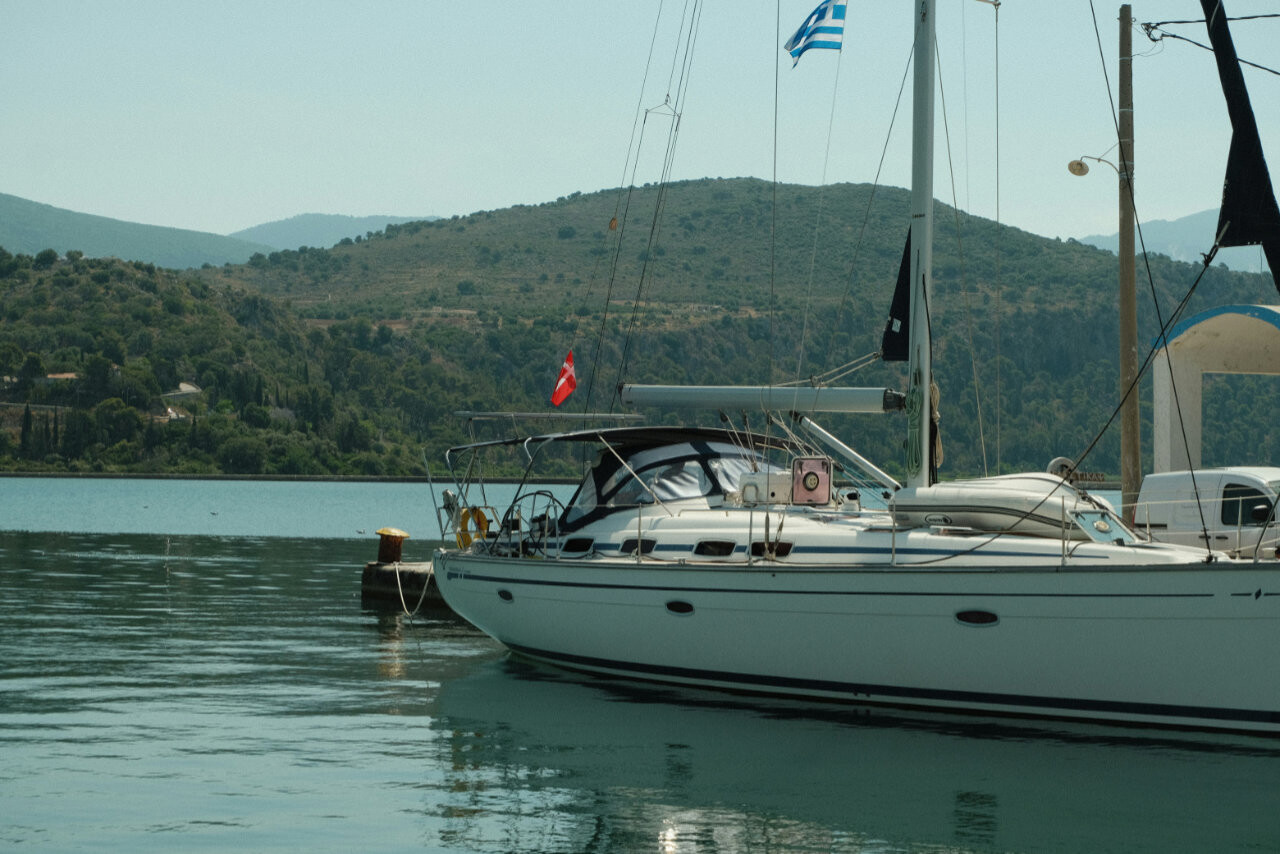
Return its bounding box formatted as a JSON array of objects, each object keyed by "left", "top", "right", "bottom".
[{"left": 435, "top": 552, "right": 1280, "bottom": 732}]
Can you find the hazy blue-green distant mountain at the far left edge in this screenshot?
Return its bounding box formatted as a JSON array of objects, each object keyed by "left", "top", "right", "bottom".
[{"left": 0, "top": 193, "right": 273, "bottom": 269}]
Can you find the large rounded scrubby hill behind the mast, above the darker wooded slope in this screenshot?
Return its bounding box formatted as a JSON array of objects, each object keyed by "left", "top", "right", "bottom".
[{"left": 202, "top": 179, "right": 1275, "bottom": 472}]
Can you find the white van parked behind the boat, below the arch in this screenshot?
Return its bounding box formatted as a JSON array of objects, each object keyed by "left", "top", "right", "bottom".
[{"left": 1133, "top": 466, "right": 1280, "bottom": 558}]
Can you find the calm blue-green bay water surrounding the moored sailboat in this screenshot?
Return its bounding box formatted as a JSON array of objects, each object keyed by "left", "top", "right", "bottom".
[{"left": 0, "top": 479, "right": 1280, "bottom": 854}]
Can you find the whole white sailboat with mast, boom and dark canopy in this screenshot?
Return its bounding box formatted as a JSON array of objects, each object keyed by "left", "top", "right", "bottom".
[{"left": 435, "top": 0, "right": 1280, "bottom": 732}]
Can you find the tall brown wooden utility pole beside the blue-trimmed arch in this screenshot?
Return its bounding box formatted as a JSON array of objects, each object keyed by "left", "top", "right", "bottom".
[{"left": 1119, "top": 4, "right": 1142, "bottom": 522}]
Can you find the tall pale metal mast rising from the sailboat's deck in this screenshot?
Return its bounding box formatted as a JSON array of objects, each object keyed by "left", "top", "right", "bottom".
[{"left": 906, "top": 0, "right": 934, "bottom": 487}]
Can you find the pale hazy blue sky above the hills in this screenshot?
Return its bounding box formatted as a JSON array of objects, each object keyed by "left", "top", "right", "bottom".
[{"left": 0, "top": 0, "right": 1280, "bottom": 241}]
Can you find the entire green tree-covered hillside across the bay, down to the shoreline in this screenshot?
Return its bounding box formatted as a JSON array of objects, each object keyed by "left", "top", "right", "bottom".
[{"left": 0, "top": 179, "right": 1280, "bottom": 476}]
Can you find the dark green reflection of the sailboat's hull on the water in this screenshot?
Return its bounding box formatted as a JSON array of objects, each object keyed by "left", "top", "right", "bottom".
[{"left": 436, "top": 659, "right": 1280, "bottom": 853}]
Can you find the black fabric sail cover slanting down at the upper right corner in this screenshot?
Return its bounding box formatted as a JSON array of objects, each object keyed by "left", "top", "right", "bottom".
[{"left": 1201, "top": 0, "right": 1280, "bottom": 291}]
